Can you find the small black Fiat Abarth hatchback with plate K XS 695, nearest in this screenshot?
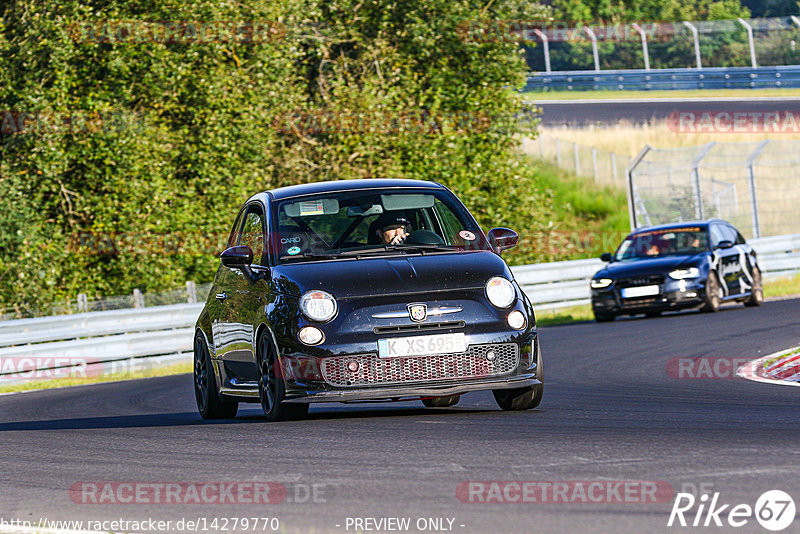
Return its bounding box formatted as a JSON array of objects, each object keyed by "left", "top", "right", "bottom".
[{"left": 194, "top": 179, "right": 543, "bottom": 421}]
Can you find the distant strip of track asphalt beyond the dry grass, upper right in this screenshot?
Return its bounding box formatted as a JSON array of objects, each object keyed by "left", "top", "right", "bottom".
[{"left": 529, "top": 95, "right": 800, "bottom": 127}]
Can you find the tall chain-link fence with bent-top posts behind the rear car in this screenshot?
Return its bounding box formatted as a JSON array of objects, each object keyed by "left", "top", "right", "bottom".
[{"left": 629, "top": 140, "right": 800, "bottom": 238}]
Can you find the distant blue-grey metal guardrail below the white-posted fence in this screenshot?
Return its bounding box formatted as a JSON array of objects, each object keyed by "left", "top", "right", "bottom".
[{"left": 523, "top": 65, "right": 800, "bottom": 92}]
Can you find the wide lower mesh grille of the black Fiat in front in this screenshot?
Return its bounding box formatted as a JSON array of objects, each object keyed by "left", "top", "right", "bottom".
[{"left": 322, "top": 343, "right": 519, "bottom": 387}]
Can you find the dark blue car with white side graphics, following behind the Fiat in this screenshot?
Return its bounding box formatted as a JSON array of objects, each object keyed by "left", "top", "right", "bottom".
[{"left": 591, "top": 219, "right": 764, "bottom": 322}]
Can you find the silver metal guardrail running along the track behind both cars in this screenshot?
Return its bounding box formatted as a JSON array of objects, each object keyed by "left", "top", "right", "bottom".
[{"left": 0, "top": 234, "right": 800, "bottom": 377}]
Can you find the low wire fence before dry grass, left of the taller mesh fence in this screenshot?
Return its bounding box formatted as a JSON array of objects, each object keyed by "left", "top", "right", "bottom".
[{"left": 522, "top": 133, "right": 632, "bottom": 187}]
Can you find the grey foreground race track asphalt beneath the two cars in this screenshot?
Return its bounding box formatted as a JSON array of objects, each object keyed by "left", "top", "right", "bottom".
[{"left": 0, "top": 299, "right": 800, "bottom": 534}]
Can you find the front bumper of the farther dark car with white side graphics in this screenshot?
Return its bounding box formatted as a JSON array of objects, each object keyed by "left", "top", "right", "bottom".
[{"left": 592, "top": 278, "right": 705, "bottom": 314}]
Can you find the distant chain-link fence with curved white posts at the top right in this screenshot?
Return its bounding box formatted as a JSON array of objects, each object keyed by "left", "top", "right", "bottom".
[{"left": 520, "top": 16, "right": 800, "bottom": 72}]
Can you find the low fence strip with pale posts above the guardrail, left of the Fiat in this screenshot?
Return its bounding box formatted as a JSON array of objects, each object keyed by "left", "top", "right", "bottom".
[{"left": 0, "top": 281, "right": 211, "bottom": 321}]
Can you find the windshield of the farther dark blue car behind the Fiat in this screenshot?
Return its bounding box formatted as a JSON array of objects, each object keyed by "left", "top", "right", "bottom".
[{"left": 615, "top": 226, "right": 708, "bottom": 261}]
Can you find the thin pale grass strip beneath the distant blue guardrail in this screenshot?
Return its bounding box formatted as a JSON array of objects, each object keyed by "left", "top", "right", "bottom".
[{"left": 522, "top": 89, "right": 800, "bottom": 100}]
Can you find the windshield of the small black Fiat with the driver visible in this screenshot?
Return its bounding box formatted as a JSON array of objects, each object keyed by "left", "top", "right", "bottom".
[{"left": 272, "top": 189, "right": 490, "bottom": 263}]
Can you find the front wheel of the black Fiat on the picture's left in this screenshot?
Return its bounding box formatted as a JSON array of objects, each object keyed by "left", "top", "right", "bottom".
[{"left": 257, "top": 331, "right": 308, "bottom": 422}]
